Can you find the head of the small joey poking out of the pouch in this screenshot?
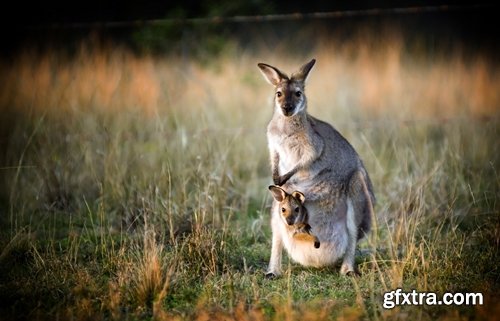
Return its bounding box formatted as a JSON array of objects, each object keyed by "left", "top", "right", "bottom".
[{"left": 269, "top": 185, "right": 307, "bottom": 225}]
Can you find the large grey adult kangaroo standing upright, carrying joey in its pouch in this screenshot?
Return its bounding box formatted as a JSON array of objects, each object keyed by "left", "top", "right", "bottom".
[{"left": 258, "top": 59, "right": 375, "bottom": 277}]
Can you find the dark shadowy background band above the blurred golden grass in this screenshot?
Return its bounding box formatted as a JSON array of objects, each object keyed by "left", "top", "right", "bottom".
[{"left": 1, "top": 0, "right": 498, "bottom": 58}]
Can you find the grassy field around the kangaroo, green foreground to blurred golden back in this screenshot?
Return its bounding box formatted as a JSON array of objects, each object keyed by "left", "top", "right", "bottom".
[{"left": 0, "top": 33, "right": 500, "bottom": 320}]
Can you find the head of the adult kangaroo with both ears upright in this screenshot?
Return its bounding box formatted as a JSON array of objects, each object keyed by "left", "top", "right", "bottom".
[{"left": 258, "top": 59, "right": 316, "bottom": 117}]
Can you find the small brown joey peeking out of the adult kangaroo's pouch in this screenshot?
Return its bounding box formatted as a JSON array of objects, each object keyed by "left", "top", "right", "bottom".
[{"left": 269, "top": 185, "right": 320, "bottom": 248}]
